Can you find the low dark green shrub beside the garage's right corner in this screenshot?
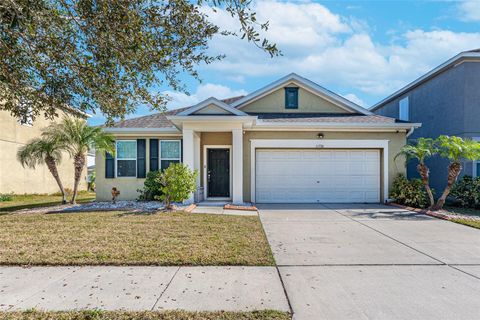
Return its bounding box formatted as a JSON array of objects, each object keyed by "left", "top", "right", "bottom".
[{"left": 390, "top": 174, "right": 429, "bottom": 208}]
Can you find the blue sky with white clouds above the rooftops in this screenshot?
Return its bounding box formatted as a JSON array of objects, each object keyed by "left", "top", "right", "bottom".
[{"left": 89, "top": 0, "right": 480, "bottom": 125}]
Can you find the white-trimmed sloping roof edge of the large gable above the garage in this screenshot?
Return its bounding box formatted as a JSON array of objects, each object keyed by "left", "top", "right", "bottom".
[{"left": 232, "top": 73, "right": 372, "bottom": 115}]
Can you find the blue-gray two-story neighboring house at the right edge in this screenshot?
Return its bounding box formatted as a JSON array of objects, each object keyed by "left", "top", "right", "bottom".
[{"left": 370, "top": 50, "right": 480, "bottom": 195}]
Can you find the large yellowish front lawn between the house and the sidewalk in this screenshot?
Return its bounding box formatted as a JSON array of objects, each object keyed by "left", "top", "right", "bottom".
[{"left": 0, "top": 212, "right": 275, "bottom": 266}]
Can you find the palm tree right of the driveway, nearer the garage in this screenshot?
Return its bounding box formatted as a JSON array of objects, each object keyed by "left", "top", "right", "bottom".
[{"left": 395, "top": 138, "right": 438, "bottom": 207}]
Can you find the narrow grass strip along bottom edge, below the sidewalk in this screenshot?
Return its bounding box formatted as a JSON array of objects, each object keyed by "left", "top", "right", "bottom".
[{"left": 0, "top": 310, "right": 291, "bottom": 320}]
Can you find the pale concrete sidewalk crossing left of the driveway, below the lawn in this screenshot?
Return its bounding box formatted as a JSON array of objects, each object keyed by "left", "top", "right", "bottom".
[{"left": 0, "top": 266, "right": 289, "bottom": 311}]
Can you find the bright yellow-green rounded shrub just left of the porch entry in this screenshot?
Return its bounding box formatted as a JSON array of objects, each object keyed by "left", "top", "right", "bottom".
[{"left": 155, "top": 163, "right": 198, "bottom": 209}]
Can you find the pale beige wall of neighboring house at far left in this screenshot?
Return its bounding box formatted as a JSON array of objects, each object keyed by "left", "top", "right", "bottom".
[{"left": 0, "top": 111, "right": 87, "bottom": 194}]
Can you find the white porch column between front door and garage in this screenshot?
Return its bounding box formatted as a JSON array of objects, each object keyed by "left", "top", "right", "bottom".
[{"left": 232, "top": 129, "right": 243, "bottom": 204}]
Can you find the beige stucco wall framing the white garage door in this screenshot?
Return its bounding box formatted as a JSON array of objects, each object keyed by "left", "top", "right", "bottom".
[{"left": 243, "top": 131, "right": 406, "bottom": 202}]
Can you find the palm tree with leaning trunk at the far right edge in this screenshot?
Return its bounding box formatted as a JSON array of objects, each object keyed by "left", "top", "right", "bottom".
[{"left": 432, "top": 136, "right": 480, "bottom": 210}]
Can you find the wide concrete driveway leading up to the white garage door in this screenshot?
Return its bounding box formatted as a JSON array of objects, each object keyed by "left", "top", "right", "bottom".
[{"left": 259, "top": 204, "right": 480, "bottom": 320}]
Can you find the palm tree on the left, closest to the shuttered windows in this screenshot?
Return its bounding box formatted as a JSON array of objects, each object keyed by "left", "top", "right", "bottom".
[{"left": 46, "top": 117, "right": 115, "bottom": 203}]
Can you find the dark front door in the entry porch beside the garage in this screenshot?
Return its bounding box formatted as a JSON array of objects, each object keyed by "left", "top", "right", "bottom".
[{"left": 207, "top": 149, "right": 230, "bottom": 198}]
